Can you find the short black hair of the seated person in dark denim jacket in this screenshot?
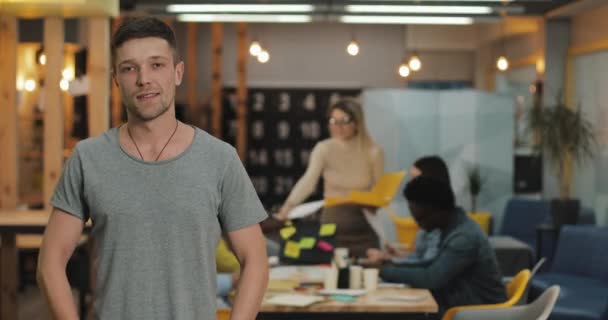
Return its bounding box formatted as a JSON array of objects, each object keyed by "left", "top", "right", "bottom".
[{"left": 403, "top": 175, "right": 456, "bottom": 211}]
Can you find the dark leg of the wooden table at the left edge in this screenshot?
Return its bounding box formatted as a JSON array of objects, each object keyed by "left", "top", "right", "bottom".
[{"left": 0, "top": 232, "right": 18, "bottom": 319}]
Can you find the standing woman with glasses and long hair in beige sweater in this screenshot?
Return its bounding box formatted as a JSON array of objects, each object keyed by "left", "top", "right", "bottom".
[{"left": 275, "top": 99, "right": 384, "bottom": 256}]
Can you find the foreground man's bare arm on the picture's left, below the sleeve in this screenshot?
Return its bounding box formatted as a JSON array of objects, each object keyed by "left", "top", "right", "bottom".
[{"left": 37, "top": 209, "right": 84, "bottom": 320}]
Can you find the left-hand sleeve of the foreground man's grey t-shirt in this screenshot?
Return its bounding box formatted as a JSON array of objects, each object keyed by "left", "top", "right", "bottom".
[{"left": 51, "top": 147, "right": 89, "bottom": 221}]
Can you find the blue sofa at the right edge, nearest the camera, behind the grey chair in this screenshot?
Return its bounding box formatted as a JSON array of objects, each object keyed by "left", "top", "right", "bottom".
[{"left": 529, "top": 225, "right": 608, "bottom": 320}]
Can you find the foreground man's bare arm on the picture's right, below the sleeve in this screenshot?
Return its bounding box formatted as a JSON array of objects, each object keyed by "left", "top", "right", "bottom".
[{"left": 228, "top": 224, "right": 268, "bottom": 320}]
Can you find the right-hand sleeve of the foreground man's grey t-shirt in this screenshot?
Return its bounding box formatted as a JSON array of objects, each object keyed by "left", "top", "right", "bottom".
[{"left": 218, "top": 150, "right": 268, "bottom": 232}]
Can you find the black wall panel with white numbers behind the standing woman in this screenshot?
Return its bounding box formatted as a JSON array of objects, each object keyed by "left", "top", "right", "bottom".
[{"left": 222, "top": 88, "right": 361, "bottom": 211}]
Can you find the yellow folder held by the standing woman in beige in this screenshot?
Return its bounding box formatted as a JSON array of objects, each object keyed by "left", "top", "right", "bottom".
[{"left": 324, "top": 171, "right": 405, "bottom": 208}]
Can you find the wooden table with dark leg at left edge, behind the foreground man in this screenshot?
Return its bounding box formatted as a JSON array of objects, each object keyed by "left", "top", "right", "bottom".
[{"left": 0, "top": 210, "right": 90, "bottom": 319}]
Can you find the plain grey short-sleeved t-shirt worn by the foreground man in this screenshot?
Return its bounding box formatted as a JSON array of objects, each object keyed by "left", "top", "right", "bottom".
[{"left": 51, "top": 128, "right": 268, "bottom": 320}]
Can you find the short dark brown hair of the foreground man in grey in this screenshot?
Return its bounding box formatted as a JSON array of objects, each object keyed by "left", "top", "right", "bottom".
[{"left": 110, "top": 17, "right": 180, "bottom": 66}]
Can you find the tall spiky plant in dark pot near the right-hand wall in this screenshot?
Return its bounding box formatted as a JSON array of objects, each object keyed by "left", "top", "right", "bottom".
[{"left": 529, "top": 97, "right": 596, "bottom": 227}]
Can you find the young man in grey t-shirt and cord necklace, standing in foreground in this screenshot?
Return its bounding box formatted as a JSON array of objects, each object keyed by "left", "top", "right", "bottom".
[{"left": 38, "top": 18, "right": 268, "bottom": 320}]
